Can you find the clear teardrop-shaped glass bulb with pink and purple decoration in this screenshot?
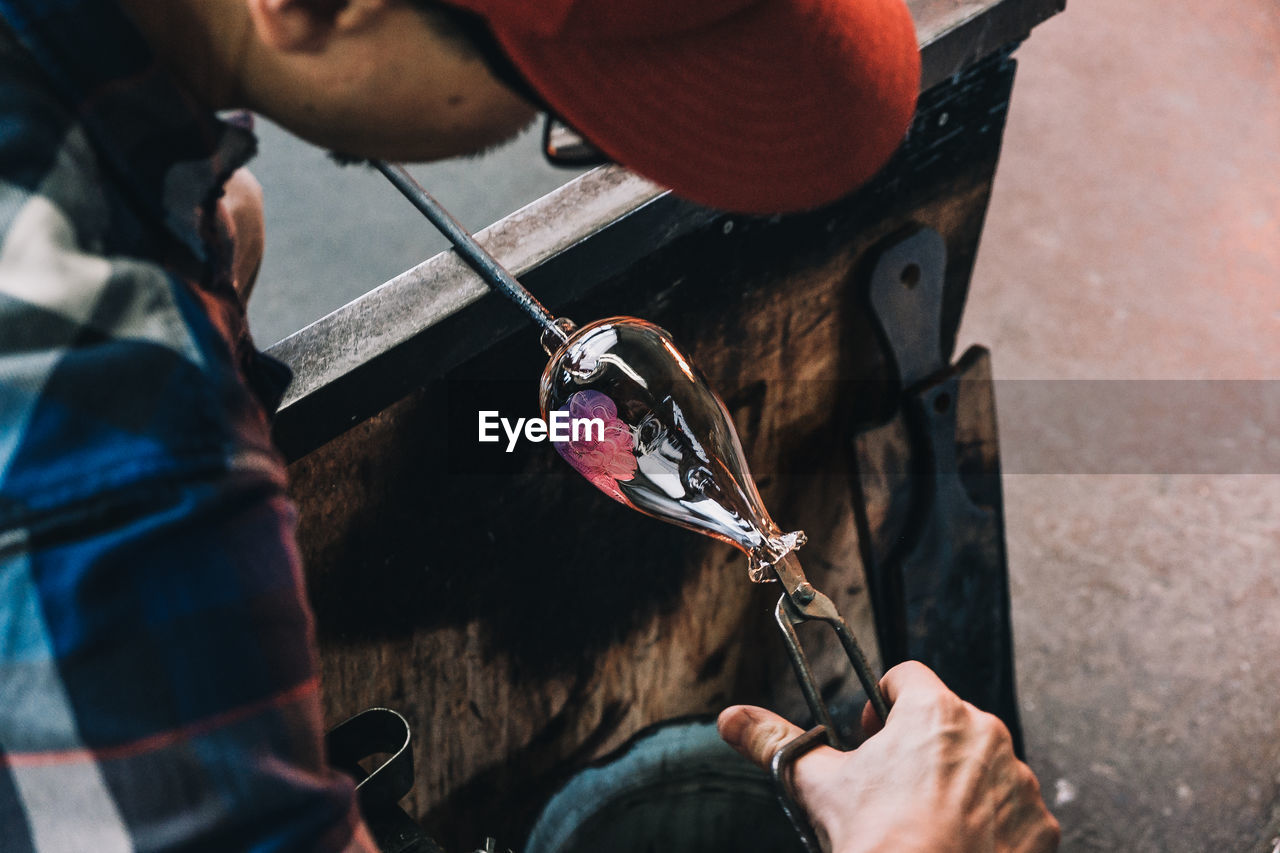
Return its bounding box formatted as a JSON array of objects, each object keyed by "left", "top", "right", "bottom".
[{"left": 540, "top": 318, "right": 805, "bottom": 583}]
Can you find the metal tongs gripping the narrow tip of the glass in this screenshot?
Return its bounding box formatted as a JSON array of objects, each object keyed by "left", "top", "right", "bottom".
[{"left": 769, "top": 552, "right": 888, "bottom": 853}]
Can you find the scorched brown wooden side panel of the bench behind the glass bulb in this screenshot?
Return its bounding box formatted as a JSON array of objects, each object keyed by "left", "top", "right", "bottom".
[{"left": 291, "top": 51, "right": 1012, "bottom": 849}]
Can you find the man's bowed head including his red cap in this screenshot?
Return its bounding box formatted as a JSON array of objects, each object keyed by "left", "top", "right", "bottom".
[{"left": 122, "top": 0, "right": 919, "bottom": 213}]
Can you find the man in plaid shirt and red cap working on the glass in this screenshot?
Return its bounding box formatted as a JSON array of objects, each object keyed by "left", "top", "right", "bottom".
[{"left": 0, "top": 0, "right": 1056, "bottom": 853}]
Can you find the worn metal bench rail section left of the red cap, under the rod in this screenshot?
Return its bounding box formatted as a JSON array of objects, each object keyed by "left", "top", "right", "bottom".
[{"left": 268, "top": 167, "right": 722, "bottom": 461}]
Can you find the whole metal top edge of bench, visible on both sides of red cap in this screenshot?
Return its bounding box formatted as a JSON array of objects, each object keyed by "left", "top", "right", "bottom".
[{"left": 268, "top": 0, "right": 1065, "bottom": 460}]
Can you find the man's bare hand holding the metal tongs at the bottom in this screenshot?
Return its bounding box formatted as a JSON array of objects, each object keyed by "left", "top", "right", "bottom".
[{"left": 718, "top": 662, "right": 1060, "bottom": 853}]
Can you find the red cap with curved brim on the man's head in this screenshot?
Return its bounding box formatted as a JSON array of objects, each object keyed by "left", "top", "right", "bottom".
[{"left": 451, "top": 0, "right": 920, "bottom": 213}]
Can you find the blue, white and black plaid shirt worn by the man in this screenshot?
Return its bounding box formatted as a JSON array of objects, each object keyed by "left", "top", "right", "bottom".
[{"left": 0, "top": 0, "right": 372, "bottom": 853}]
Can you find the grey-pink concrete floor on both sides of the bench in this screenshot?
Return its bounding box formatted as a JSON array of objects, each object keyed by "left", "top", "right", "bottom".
[{"left": 251, "top": 0, "right": 1280, "bottom": 853}]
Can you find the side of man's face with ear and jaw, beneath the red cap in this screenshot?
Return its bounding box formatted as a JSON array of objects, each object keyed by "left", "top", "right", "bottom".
[{"left": 241, "top": 0, "right": 535, "bottom": 160}]
